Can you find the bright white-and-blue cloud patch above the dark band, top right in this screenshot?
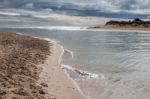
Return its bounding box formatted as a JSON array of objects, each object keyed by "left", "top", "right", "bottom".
[{"left": 58, "top": 0, "right": 150, "bottom": 13}]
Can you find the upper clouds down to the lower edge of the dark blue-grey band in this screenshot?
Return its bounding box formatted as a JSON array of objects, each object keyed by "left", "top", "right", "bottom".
[{"left": 0, "top": 0, "right": 150, "bottom": 19}]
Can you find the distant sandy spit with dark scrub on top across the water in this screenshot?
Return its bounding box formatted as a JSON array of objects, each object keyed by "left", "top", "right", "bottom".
[{"left": 87, "top": 18, "right": 150, "bottom": 31}]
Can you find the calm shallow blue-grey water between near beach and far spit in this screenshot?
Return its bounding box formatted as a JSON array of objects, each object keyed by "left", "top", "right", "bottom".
[{"left": 0, "top": 28, "right": 150, "bottom": 99}]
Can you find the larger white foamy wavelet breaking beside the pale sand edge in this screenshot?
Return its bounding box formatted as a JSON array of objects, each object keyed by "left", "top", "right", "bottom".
[{"left": 61, "top": 64, "right": 99, "bottom": 79}]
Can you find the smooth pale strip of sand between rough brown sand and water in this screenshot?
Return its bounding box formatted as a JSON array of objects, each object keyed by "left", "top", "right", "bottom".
[{"left": 40, "top": 38, "right": 87, "bottom": 99}]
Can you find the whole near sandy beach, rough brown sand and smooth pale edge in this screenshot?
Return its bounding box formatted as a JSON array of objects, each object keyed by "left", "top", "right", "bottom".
[{"left": 0, "top": 33, "right": 85, "bottom": 99}]
